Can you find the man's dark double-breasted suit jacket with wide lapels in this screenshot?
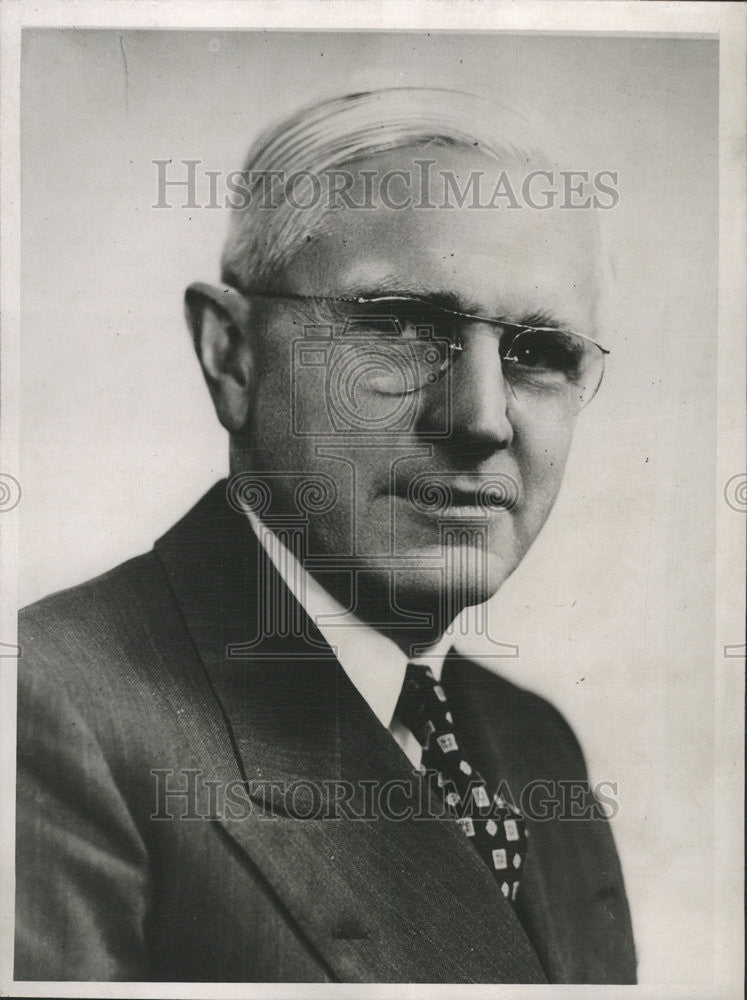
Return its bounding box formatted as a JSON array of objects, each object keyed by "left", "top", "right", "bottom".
[{"left": 15, "top": 484, "right": 635, "bottom": 983}]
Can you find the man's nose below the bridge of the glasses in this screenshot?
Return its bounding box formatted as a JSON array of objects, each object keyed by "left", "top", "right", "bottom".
[{"left": 423, "top": 324, "right": 514, "bottom": 466}]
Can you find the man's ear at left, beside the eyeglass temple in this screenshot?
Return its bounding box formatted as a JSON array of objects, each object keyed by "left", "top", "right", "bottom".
[{"left": 184, "top": 281, "right": 256, "bottom": 434}]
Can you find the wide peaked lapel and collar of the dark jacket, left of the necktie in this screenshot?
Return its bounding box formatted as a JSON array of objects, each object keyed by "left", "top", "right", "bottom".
[{"left": 156, "top": 484, "right": 543, "bottom": 982}]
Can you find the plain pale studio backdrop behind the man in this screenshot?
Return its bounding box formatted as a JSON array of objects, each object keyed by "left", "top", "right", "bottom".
[{"left": 19, "top": 30, "right": 718, "bottom": 985}]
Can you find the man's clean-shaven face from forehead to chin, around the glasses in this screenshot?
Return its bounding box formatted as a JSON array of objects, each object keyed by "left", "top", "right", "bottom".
[{"left": 248, "top": 148, "right": 597, "bottom": 611}]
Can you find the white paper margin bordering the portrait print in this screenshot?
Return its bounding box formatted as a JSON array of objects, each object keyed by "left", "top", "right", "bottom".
[{"left": 0, "top": 0, "right": 747, "bottom": 1000}]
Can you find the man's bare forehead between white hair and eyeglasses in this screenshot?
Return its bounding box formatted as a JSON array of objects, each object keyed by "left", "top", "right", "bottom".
[{"left": 286, "top": 146, "right": 598, "bottom": 332}]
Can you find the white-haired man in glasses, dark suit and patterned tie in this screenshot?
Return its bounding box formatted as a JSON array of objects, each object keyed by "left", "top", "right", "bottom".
[{"left": 15, "top": 89, "right": 635, "bottom": 983}]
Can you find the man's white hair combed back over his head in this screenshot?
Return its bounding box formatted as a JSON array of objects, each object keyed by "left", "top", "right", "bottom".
[{"left": 221, "top": 87, "right": 546, "bottom": 291}]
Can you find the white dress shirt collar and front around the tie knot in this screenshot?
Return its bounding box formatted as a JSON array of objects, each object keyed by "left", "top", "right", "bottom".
[{"left": 247, "top": 511, "right": 450, "bottom": 767}]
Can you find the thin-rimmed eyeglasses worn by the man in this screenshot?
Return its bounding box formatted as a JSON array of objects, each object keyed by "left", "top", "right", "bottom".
[{"left": 247, "top": 292, "right": 609, "bottom": 413}]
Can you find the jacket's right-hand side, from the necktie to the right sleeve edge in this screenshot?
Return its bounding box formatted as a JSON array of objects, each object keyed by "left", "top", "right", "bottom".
[{"left": 442, "top": 654, "right": 635, "bottom": 983}]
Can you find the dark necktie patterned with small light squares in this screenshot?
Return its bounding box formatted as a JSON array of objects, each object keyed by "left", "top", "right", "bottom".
[{"left": 394, "top": 663, "right": 527, "bottom": 903}]
